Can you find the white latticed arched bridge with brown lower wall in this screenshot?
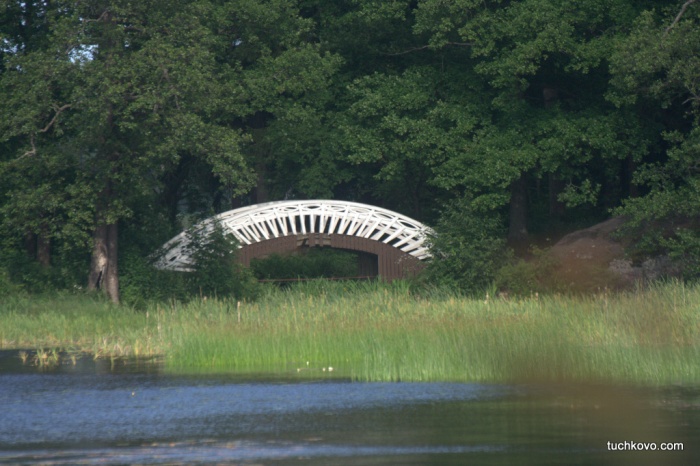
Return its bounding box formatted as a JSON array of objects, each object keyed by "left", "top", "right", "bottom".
[{"left": 157, "top": 200, "right": 430, "bottom": 280}]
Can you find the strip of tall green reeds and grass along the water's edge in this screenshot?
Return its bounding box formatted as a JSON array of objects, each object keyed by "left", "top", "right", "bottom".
[{"left": 0, "top": 283, "right": 700, "bottom": 384}]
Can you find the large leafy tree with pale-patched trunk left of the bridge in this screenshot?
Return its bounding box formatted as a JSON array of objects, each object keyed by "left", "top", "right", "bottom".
[{"left": 0, "top": 0, "right": 249, "bottom": 302}]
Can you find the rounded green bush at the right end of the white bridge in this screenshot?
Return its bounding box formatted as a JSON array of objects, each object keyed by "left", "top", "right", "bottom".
[{"left": 426, "top": 199, "right": 509, "bottom": 293}]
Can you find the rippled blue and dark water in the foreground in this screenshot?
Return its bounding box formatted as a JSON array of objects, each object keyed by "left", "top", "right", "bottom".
[{"left": 0, "top": 353, "right": 700, "bottom": 465}]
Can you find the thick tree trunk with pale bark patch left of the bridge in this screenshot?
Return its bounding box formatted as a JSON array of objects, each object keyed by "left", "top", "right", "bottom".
[{"left": 88, "top": 223, "right": 119, "bottom": 303}]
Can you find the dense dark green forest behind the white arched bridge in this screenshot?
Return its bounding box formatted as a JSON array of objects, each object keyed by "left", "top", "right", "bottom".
[{"left": 0, "top": 0, "right": 700, "bottom": 301}]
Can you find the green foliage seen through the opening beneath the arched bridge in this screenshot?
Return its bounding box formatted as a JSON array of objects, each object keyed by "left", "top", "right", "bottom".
[{"left": 250, "top": 248, "right": 359, "bottom": 280}]
